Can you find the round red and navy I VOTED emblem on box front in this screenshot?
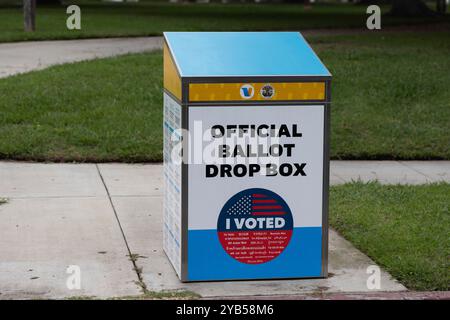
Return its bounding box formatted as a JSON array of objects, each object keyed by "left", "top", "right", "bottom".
[{"left": 217, "top": 188, "right": 293, "bottom": 264}]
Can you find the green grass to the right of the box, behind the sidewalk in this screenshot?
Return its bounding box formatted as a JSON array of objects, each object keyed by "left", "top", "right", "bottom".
[{"left": 320, "top": 32, "right": 450, "bottom": 159}]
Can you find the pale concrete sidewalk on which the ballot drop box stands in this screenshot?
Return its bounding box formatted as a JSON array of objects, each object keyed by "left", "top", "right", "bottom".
[{"left": 0, "top": 161, "right": 450, "bottom": 299}]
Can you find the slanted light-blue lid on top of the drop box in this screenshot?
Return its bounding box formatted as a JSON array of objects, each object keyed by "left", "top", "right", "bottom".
[{"left": 164, "top": 32, "right": 331, "bottom": 77}]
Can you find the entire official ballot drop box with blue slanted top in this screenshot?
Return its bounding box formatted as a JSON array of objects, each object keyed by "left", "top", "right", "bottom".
[{"left": 163, "top": 32, "right": 331, "bottom": 281}]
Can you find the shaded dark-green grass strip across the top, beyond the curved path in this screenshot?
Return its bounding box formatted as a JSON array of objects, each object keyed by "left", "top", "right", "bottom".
[{"left": 0, "top": 1, "right": 450, "bottom": 42}]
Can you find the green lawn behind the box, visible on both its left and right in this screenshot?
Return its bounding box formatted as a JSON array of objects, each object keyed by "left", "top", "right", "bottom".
[{"left": 0, "top": 32, "right": 450, "bottom": 162}]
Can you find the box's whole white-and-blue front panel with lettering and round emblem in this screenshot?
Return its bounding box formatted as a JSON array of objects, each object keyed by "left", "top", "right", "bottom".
[{"left": 187, "top": 104, "right": 325, "bottom": 281}]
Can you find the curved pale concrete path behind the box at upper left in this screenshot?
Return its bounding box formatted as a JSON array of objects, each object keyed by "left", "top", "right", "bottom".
[{"left": 0, "top": 37, "right": 162, "bottom": 78}]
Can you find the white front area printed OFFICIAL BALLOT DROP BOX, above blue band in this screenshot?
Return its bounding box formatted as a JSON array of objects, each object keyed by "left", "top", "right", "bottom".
[{"left": 188, "top": 105, "right": 324, "bottom": 230}]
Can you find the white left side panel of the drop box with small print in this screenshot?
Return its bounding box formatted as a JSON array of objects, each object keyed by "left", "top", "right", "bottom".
[{"left": 163, "top": 92, "right": 182, "bottom": 277}]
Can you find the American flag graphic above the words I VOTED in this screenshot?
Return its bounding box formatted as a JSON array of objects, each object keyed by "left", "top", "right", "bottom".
[{"left": 227, "top": 193, "right": 286, "bottom": 216}]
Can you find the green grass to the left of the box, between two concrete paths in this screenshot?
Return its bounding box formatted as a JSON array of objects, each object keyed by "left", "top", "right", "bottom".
[{"left": 0, "top": 52, "right": 162, "bottom": 161}]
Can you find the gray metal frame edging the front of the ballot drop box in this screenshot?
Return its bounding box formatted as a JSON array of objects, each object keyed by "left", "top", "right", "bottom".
[{"left": 165, "top": 38, "right": 331, "bottom": 282}]
